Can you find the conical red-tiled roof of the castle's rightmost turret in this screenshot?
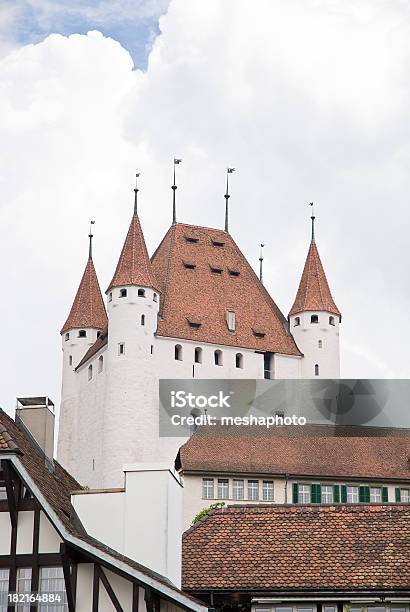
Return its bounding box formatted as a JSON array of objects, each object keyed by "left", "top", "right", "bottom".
[{"left": 289, "top": 240, "right": 341, "bottom": 317}]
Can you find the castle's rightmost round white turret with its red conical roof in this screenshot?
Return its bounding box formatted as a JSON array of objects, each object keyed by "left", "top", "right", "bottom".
[{"left": 289, "top": 209, "right": 342, "bottom": 378}]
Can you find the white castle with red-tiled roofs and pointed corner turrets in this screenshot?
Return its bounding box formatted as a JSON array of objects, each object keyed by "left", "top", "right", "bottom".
[{"left": 58, "top": 180, "right": 341, "bottom": 488}]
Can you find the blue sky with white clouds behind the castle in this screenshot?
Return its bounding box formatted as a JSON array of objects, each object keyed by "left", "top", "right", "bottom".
[{"left": 0, "top": 0, "right": 410, "bottom": 411}]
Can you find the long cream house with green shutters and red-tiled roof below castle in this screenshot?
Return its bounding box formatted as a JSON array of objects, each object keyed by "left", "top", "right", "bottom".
[{"left": 175, "top": 425, "right": 410, "bottom": 529}]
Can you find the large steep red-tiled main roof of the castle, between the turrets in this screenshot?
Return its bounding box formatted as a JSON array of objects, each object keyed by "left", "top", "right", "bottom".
[{"left": 152, "top": 224, "right": 300, "bottom": 355}]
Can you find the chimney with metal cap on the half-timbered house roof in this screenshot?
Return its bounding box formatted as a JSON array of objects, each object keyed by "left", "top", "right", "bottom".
[{"left": 15, "top": 397, "right": 55, "bottom": 465}]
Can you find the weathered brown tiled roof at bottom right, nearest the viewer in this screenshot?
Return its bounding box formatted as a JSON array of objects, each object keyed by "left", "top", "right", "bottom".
[{"left": 182, "top": 504, "right": 410, "bottom": 591}]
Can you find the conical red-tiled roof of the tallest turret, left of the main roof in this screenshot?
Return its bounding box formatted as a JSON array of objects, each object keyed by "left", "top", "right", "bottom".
[{"left": 107, "top": 215, "right": 157, "bottom": 291}]
